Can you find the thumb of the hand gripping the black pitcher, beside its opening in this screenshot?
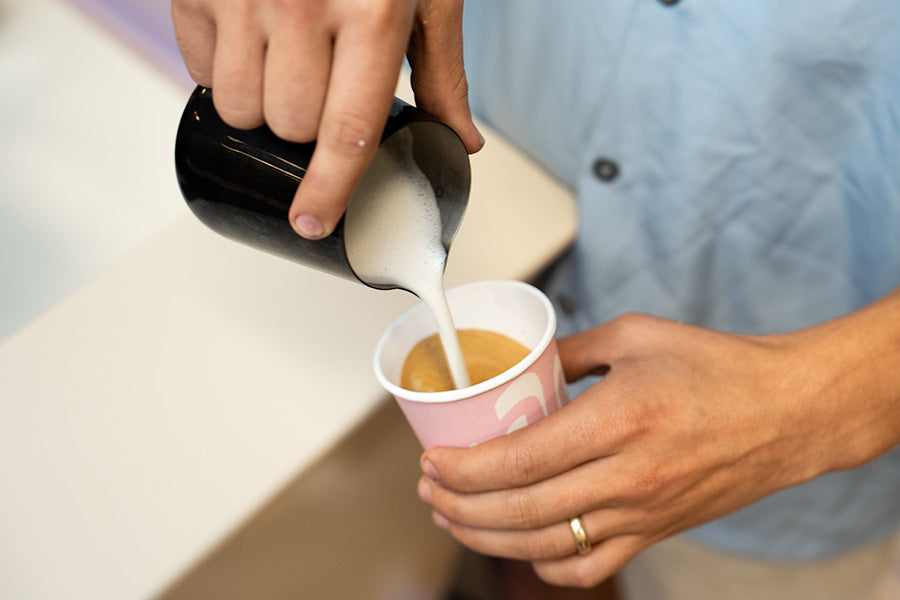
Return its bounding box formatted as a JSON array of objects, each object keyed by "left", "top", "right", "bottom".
[{"left": 407, "top": 1, "right": 484, "bottom": 153}]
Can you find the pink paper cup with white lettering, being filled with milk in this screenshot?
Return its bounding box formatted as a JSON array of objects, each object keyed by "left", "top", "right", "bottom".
[{"left": 374, "top": 280, "right": 568, "bottom": 448}]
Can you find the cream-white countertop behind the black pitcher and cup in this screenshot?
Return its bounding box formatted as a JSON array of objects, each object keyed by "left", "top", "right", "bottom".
[{"left": 0, "top": 0, "right": 575, "bottom": 600}]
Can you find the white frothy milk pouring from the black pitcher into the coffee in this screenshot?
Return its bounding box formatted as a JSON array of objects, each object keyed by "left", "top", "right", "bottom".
[{"left": 344, "top": 131, "right": 469, "bottom": 389}]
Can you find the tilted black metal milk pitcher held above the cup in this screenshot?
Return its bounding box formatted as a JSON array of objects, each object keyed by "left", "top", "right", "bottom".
[{"left": 175, "top": 87, "right": 471, "bottom": 289}]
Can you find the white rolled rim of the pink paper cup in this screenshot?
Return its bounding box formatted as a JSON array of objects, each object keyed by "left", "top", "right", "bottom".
[{"left": 372, "top": 279, "right": 556, "bottom": 404}]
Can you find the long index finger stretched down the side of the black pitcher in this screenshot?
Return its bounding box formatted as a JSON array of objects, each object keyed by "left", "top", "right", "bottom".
[{"left": 289, "top": 11, "right": 412, "bottom": 239}]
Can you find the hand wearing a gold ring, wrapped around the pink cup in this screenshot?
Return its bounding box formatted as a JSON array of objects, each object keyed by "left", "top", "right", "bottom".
[{"left": 419, "top": 293, "right": 900, "bottom": 587}]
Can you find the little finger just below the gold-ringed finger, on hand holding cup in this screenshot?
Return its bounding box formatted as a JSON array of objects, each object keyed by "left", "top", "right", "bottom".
[{"left": 532, "top": 535, "right": 649, "bottom": 588}]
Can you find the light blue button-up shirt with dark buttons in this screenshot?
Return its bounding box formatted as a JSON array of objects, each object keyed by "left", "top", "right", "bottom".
[{"left": 464, "top": 0, "right": 900, "bottom": 559}]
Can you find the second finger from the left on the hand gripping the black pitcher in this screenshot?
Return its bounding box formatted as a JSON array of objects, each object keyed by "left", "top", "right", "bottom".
[{"left": 212, "top": 3, "right": 266, "bottom": 129}]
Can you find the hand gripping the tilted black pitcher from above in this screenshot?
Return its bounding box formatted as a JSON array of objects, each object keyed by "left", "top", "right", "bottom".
[{"left": 172, "top": 0, "right": 484, "bottom": 239}]
